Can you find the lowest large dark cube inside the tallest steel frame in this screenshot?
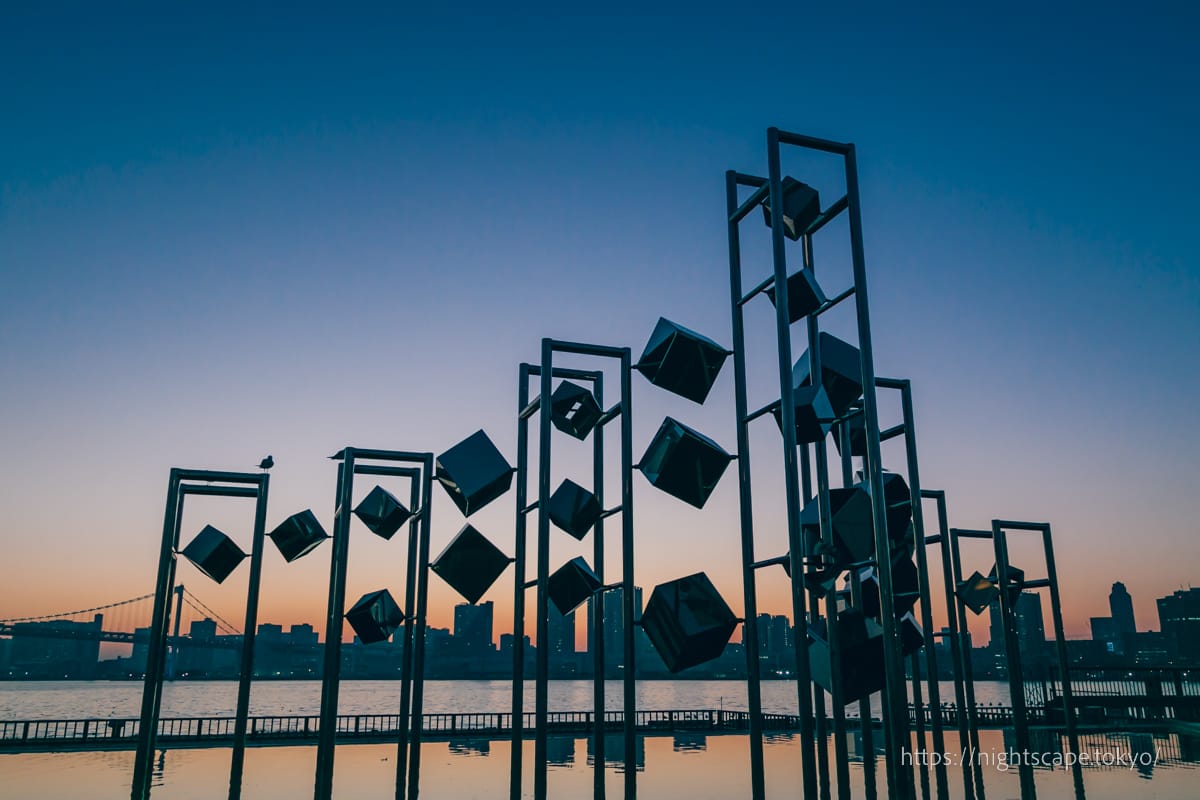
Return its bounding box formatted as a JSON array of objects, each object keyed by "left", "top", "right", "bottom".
[{"left": 809, "top": 608, "right": 884, "bottom": 703}]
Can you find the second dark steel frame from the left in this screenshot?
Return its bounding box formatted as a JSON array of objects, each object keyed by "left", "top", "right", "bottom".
[{"left": 313, "top": 447, "right": 433, "bottom": 800}]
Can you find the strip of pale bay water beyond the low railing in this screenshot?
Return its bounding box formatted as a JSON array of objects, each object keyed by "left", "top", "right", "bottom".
[{"left": 0, "top": 680, "right": 1008, "bottom": 720}]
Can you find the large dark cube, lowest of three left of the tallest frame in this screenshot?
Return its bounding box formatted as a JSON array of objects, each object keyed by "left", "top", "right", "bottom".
[{"left": 642, "top": 572, "right": 738, "bottom": 673}]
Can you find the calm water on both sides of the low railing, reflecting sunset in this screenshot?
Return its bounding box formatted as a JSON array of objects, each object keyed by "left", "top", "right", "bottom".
[{"left": 0, "top": 681, "right": 1200, "bottom": 800}]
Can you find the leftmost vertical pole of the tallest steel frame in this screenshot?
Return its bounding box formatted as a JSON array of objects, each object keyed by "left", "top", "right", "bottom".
[{"left": 725, "top": 170, "right": 768, "bottom": 800}]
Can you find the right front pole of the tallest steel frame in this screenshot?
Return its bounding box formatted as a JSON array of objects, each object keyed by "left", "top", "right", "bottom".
[{"left": 840, "top": 140, "right": 913, "bottom": 800}]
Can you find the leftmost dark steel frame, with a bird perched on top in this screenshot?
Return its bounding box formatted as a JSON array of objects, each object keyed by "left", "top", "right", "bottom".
[{"left": 130, "top": 467, "right": 270, "bottom": 800}]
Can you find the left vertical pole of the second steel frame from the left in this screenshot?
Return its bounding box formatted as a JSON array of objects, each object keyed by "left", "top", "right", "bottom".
[{"left": 313, "top": 455, "right": 354, "bottom": 800}]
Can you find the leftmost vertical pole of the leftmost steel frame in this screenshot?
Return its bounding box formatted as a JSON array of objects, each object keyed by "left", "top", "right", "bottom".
[{"left": 130, "top": 468, "right": 181, "bottom": 800}]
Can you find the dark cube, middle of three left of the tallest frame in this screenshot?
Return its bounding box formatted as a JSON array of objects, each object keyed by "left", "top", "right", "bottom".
[{"left": 640, "top": 416, "right": 733, "bottom": 509}]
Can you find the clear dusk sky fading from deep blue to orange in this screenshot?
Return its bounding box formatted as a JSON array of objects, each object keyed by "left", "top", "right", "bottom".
[{"left": 0, "top": 2, "right": 1200, "bottom": 652}]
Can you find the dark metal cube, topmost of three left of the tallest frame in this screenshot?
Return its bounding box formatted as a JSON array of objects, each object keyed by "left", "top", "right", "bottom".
[{"left": 636, "top": 317, "right": 730, "bottom": 403}]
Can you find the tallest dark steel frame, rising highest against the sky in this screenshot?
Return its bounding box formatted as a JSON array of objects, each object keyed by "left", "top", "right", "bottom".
[{"left": 726, "top": 127, "right": 912, "bottom": 799}]
